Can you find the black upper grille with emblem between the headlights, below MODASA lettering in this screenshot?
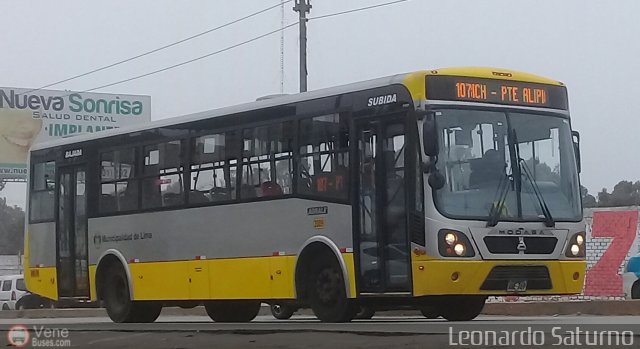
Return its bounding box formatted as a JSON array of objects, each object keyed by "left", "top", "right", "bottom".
[{"left": 484, "top": 236, "right": 558, "bottom": 254}]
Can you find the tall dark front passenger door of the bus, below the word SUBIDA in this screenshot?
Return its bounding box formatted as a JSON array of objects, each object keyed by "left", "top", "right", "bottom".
[{"left": 355, "top": 116, "right": 411, "bottom": 294}]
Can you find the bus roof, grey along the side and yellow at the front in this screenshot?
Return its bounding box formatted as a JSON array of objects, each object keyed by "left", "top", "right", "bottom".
[{"left": 31, "top": 67, "right": 564, "bottom": 151}]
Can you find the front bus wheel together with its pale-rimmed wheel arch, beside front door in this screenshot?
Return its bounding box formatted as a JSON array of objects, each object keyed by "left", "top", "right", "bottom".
[{"left": 295, "top": 237, "right": 357, "bottom": 322}]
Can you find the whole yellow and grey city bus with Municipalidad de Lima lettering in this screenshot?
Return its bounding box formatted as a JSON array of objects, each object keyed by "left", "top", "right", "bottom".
[{"left": 25, "top": 68, "right": 586, "bottom": 322}]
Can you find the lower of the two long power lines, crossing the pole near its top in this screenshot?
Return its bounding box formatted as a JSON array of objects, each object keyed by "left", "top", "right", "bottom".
[{"left": 60, "top": 0, "right": 409, "bottom": 93}]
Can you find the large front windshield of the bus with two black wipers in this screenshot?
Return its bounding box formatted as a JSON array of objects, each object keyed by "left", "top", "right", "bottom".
[{"left": 434, "top": 109, "right": 582, "bottom": 225}]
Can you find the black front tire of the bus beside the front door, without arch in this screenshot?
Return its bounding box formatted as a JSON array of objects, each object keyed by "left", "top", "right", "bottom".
[{"left": 307, "top": 255, "right": 357, "bottom": 322}]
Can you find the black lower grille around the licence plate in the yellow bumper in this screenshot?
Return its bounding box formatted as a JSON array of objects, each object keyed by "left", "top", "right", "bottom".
[{"left": 480, "top": 266, "right": 552, "bottom": 291}]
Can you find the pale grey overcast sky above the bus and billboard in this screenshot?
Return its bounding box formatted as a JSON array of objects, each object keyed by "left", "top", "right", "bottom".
[{"left": 0, "top": 0, "right": 640, "bottom": 205}]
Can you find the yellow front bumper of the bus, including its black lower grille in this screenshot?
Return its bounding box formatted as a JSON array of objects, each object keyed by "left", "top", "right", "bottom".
[{"left": 412, "top": 259, "right": 586, "bottom": 296}]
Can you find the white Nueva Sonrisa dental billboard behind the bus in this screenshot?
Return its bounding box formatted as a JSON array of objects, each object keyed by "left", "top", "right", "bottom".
[{"left": 0, "top": 87, "right": 151, "bottom": 179}]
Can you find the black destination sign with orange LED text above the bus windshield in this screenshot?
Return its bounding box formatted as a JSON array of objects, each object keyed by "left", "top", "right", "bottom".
[{"left": 426, "top": 76, "right": 568, "bottom": 110}]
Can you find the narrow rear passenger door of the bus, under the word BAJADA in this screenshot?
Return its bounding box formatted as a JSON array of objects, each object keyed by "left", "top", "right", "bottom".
[{"left": 56, "top": 166, "right": 89, "bottom": 297}]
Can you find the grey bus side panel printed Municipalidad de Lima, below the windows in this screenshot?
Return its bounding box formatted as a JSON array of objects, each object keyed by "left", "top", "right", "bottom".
[{"left": 89, "top": 198, "right": 353, "bottom": 264}]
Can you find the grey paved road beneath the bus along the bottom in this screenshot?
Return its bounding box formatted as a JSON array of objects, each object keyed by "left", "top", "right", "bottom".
[{"left": 0, "top": 316, "right": 640, "bottom": 349}]
